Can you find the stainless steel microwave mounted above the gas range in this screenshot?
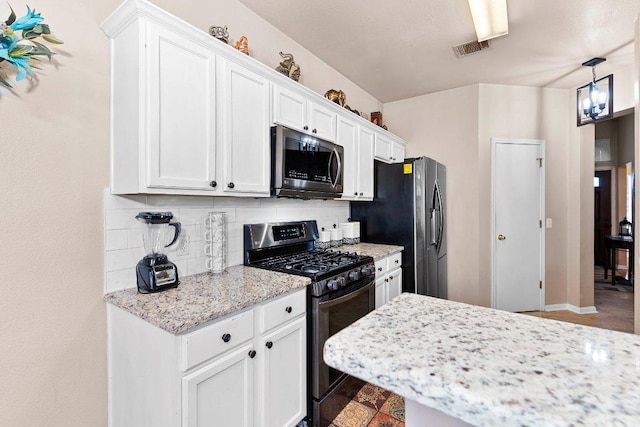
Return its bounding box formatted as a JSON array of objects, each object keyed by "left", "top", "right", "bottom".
[{"left": 271, "top": 126, "right": 344, "bottom": 199}]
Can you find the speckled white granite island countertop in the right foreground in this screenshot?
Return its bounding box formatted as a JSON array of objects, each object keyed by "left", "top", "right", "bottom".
[{"left": 324, "top": 294, "right": 640, "bottom": 427}]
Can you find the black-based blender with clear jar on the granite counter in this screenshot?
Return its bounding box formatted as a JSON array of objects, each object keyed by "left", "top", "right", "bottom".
[{"left": 136, "top": 212, "right": 181, "bottom": 294}]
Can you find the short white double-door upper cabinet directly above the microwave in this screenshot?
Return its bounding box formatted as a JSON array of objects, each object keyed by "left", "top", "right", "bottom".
[{"left": 273, "top": 84, "right": 336, "bottom": 142}]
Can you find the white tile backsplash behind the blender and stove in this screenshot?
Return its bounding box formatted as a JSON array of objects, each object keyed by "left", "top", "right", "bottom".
[{"left": 104, "top": 189, "right": 349, "bottom": 293}]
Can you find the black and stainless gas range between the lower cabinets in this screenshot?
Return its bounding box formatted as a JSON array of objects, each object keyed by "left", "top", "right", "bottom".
[{"left": 244, "top": 221, "right": 375, "bottom": 427}]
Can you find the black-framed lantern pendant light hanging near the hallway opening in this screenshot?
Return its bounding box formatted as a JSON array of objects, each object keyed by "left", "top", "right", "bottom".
[{"left": 577, "top": 58, "right": 613, "bottom": 126}]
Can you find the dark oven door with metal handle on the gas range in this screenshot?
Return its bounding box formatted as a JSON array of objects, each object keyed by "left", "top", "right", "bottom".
[{"left": 309, "top": 277, "right": 375, "bottom": 400}]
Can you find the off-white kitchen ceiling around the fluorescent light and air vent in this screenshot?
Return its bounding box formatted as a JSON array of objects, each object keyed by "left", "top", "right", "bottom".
[{"left": 239, "top": 0, "right": 640, "bottom": 102}]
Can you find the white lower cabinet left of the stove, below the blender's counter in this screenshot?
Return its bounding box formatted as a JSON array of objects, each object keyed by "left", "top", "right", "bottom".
[{"left": 108, "top": 289, "right": 307, "bottom": 427}]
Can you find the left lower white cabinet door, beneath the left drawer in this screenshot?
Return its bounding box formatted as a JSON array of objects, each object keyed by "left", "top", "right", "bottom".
[{"left": 182, "top": 345, "right": 255, "bottom": 427}]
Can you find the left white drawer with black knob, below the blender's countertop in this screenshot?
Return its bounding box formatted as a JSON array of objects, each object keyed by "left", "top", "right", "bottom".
[{"left": 182, "top": 310, "right": 253, "bottom": 371}]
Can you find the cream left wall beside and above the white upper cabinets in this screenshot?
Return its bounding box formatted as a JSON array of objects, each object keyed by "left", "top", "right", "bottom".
[{"left": 0, "top": 0, "right": 381, "bottom": 427}]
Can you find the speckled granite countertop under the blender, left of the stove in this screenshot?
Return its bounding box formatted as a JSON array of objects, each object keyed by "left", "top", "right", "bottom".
[{"left": 104, "top": 265, "right": 311, "bottom": 335}]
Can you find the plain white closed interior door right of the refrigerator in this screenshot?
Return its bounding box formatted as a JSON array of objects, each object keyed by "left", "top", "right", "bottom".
[{"left": 492, "top": 139, "right": 544, "bottom": 311}]
